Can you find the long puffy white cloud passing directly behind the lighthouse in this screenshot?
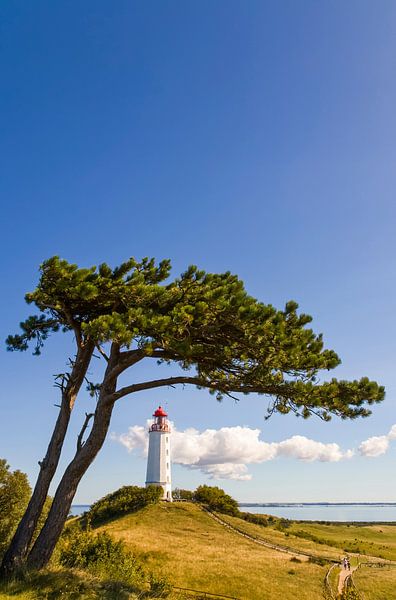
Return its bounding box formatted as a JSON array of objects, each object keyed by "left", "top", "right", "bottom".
[{"left": 112, "top": 422, "right": 353, "bottom": 480}]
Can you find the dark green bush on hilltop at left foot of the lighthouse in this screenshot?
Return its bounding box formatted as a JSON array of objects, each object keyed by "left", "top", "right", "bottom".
[{"left": 85, "top": 485, "right": 163, "bottom": 525}]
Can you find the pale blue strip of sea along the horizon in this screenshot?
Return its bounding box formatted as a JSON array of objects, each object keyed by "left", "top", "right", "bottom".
[{"left": 70, "top": 502, "right": 396, "bottom": 523}]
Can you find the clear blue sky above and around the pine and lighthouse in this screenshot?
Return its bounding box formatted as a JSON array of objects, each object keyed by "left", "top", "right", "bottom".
[{"left": 0, "top": 0, "right": 396, "bottom": 502}]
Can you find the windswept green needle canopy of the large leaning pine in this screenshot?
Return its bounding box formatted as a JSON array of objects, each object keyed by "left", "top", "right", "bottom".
[{"left": 7, "top": 257, "right": 384, "bottom": 420}]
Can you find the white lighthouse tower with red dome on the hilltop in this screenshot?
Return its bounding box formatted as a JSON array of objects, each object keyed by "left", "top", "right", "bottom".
[{"left": 146, "top": 406, "right": 172, "bottom": 502}]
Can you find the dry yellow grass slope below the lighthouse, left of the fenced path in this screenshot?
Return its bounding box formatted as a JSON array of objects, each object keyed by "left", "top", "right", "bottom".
[{"left": 103, "top": 503, "right": 326, "bottom": 600}]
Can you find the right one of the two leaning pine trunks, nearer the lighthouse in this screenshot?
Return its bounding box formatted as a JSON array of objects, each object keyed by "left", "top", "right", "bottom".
[{"left": 28, "top": 352, "right": 116, "bottom": 569}]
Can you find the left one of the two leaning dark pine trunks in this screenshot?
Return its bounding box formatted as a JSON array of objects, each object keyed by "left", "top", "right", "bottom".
[{"left": 0, "top": 343, "right": 94, "bottom": 579}]
